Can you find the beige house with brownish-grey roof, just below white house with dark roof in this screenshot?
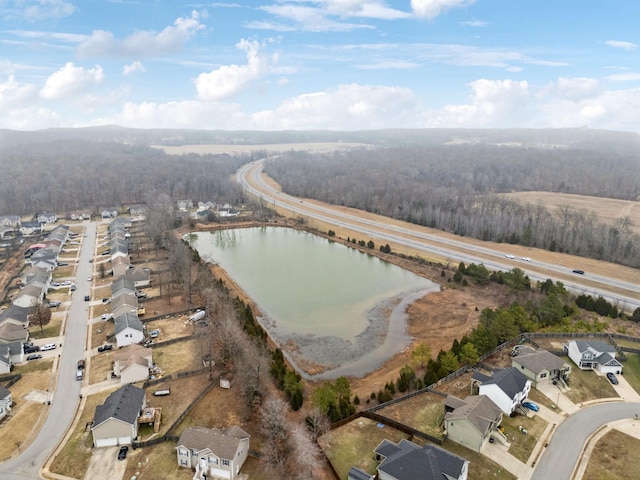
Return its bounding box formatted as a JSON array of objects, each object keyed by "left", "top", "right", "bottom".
[{"left": 444, "top": 395, "right": 507, "bottom": 452}]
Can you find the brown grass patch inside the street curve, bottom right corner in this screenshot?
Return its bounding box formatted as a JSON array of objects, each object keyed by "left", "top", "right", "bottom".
[{"left": 582, "top": 430, "right": 640, "bottom": 480}]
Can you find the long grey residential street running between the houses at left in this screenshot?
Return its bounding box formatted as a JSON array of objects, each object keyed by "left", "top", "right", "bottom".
[{"left": 0, "top": 222, "right": 96, "bottom": 480}]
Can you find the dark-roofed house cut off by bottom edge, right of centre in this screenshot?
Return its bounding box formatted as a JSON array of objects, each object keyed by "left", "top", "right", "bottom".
[{"left": 374, "top": 439, "right": 469, "bottom": 480}]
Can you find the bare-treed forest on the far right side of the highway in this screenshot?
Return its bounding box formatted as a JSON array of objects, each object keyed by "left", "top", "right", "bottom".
[{"left": 265, "top": 144, "right": 640, "bottom": 267}]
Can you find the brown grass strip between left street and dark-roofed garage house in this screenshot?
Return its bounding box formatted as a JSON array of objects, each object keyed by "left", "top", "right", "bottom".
[{"left": 51, "top": 388, "right": 116, "bottom": 478}]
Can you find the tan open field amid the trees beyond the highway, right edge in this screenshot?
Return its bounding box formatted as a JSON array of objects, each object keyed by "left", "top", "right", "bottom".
[{"left": 502, "top": 192, "right": 640, "bottom": 234}]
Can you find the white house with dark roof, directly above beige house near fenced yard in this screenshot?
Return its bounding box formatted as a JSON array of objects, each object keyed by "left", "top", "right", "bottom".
[{"left": 472, "top": 367, "right": 531, "bottom": 415}]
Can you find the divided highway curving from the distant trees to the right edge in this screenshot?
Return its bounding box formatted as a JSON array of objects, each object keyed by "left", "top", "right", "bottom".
[{"left": 236, "top": 159, "right": 640, "bottom": 312}]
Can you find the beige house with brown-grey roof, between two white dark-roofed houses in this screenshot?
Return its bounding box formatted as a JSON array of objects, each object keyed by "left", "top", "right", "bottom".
[{"left": 511, "top": 346, "right": 571, "bottom": 388}]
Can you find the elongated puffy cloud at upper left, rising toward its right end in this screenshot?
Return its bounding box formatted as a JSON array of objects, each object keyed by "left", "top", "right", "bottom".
[{"left": 77, "top": 11, "right": 205, "bottom": 57}]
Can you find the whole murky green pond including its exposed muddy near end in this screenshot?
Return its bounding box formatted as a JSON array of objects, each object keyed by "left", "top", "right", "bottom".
[{"left": 192, "top": 227, "right": 439, "bottom": 379}]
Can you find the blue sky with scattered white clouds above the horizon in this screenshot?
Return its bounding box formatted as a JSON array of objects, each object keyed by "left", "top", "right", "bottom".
[{"left": 0, "top": 0, "right": 640, "bottom": 132}]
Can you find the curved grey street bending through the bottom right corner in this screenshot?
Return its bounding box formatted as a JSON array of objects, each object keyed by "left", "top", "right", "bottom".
[{"left": 531, "top": 402, "right": 640, "bottom": 480}]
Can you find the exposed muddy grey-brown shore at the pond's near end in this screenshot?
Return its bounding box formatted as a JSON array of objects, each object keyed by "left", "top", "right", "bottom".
[{"left": 258, "top": 285, "right": 440, "bottom": 380}]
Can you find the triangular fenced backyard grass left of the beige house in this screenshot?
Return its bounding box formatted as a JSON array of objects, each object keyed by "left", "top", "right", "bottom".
[{"left": 377, "top": 393, "right": 445, "bottom": 438}]
